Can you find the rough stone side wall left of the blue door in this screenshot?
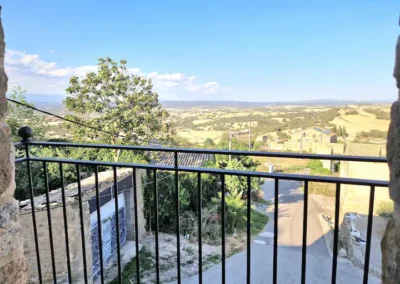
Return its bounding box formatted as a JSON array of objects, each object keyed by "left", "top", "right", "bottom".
[{"left": 20, "top": 202, "right": 92, "bottom": 283}]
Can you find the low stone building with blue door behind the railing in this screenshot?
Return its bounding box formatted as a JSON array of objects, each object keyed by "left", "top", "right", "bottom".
[{"left": 20, "top": 169, "right": 145, "bottom": 283}]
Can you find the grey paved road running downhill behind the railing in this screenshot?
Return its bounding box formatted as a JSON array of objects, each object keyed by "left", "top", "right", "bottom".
[{"left": 182, "top": 173, "right": 380, "bottom": 284}]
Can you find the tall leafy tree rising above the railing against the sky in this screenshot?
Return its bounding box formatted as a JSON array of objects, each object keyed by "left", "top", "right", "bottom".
[{"left": 64, "top": 57, "right": 169, "bottom": 161}]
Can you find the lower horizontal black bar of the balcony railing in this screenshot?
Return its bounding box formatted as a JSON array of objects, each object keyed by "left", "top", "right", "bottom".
[{"left": 19, "top": 157, "right": 389, "bottom": 187}]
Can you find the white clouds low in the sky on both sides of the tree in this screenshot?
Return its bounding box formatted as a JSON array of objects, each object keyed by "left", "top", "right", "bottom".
[{"left": 5, "top": 50, "right": 229, "bottom": 95}]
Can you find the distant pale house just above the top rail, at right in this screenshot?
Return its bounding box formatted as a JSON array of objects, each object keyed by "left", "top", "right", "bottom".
[{"left": 291, "top": 127, "right": 337, "bottom": 144}]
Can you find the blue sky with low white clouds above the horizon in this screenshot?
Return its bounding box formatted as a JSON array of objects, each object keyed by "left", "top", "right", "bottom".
[{"left": 2, "top": 0, "right": 400, "bottom": 101}]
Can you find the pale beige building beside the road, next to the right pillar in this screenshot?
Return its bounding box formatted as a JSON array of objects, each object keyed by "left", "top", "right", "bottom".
[{"left": 340, "top": 143, "right": 390, "bottom": 213}]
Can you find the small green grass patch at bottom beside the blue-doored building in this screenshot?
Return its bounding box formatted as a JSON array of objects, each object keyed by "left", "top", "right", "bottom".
[{"left": 110, "top": 248, "right": 156, "bottom": 284}]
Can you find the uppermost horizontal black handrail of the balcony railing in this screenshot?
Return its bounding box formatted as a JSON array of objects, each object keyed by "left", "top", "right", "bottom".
[{"left": 15, "top": 142, "right": 387, "bottom": 163}]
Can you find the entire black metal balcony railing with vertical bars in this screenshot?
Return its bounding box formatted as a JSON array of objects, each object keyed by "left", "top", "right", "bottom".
[{"left": 15, "top": 127, "right": 388, "bottom": 283}]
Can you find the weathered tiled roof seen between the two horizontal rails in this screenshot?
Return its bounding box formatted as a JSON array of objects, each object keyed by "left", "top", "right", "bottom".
[{"left": 149, "top": 152, "right": 214, "bottom": 167}]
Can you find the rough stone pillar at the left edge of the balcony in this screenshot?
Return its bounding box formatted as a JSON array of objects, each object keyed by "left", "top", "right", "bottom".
[{"left": 0, "top": 7, "right": 28, "bottom": 284}]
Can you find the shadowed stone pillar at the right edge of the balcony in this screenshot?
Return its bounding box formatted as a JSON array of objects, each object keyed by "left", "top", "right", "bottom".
[{"left": 381, "top": 18, "right": 400, "bottom": 284}]
